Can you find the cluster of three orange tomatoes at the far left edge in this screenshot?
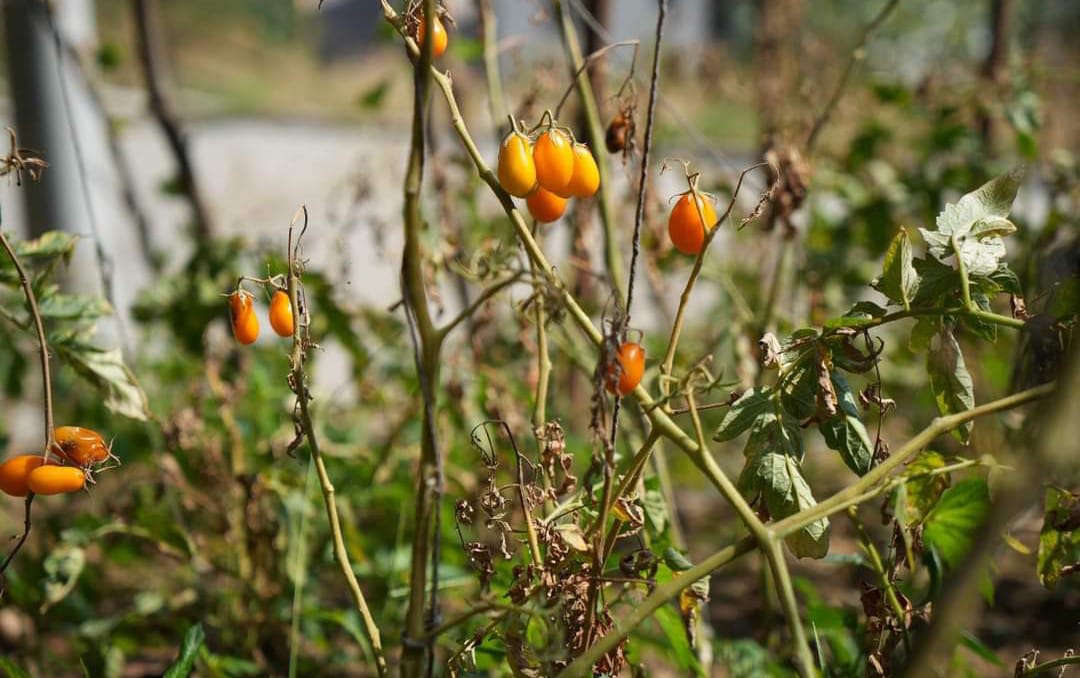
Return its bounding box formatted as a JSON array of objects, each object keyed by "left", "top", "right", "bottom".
[{"left": 0, "top": 426, "right": 116, "bottom": 497}]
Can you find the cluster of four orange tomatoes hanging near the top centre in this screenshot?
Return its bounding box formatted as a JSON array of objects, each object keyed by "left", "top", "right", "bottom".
[{"left": 498, "top": 113, "right": 600, "bottom": 223}]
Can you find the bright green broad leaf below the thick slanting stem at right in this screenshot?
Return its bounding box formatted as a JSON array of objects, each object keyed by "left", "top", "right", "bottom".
[{"left": 922, "top": 478, "right": 990, "bottom": 567}]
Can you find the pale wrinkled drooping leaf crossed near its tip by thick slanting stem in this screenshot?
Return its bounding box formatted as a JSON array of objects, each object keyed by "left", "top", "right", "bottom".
[{"left": 740, "top": 452, "right": 828, "bottom": 558}]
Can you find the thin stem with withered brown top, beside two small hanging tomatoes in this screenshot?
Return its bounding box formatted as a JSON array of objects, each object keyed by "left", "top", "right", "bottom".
[{"left": 288, "top": 207, "right": 387, "bottom": 678}]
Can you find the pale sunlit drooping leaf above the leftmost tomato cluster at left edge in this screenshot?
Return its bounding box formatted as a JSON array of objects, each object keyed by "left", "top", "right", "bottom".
[{"left": 52, "top": 341, "right": 150, "bottom": 421}]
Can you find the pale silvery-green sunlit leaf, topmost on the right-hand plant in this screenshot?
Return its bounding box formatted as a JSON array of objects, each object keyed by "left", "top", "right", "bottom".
[{"left": 919, "top": 167, "right": 1024, "bottom": 275}]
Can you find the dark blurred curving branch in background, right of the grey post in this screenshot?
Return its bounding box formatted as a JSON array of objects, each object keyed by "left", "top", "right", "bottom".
[{"left": 132, "top": 0, "right": 213, "bottom": 241}]
